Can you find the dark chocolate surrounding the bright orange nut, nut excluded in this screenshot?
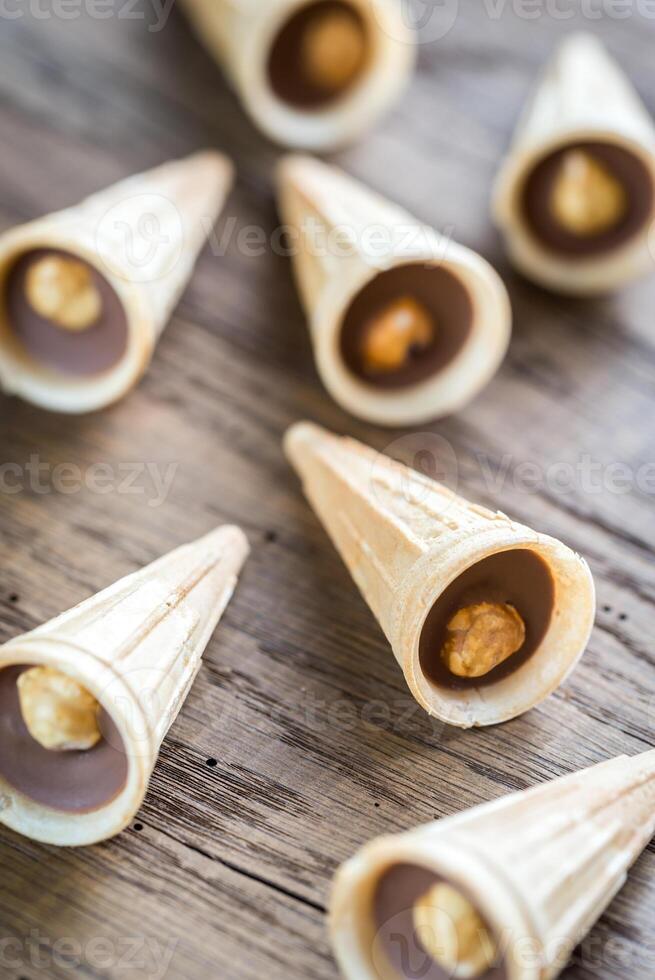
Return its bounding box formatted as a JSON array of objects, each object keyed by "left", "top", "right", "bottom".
[{"left": 340, "top": 262, "right": 473, "bottom": 388}]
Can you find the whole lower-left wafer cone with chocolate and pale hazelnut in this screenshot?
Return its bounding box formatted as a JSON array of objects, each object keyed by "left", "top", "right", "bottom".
[{"left": 0, "top": 527, "right": 248, "bottom": 846}]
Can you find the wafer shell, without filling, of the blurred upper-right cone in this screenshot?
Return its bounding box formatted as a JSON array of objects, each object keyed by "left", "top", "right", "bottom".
[{"left": 494, "top": 34, "right": 655, "bottom": 295}]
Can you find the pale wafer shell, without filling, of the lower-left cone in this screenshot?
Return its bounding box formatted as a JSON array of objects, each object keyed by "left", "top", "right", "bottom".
[{"left": 0, "top": 526, "right": 248, "bottom": 845}]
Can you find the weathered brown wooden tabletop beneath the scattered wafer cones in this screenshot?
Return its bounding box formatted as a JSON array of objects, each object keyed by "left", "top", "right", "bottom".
[{"left": 0, "top": 0, "right": 655, "bottom": 980}]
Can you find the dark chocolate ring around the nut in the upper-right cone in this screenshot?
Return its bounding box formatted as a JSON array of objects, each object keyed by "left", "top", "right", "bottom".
[{"left": 521, "top": 142, "right": 655, "bottom": 259}]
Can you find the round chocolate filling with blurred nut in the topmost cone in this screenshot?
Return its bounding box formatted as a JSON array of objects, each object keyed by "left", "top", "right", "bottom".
[{"left": 268, "top": 0, "right": 370, "bottom": 110}]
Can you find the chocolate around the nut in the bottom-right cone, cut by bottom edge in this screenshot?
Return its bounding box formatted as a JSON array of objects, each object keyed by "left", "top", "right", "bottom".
[{"left": 373, "top": 864, "right": 507, "bottom": 980}]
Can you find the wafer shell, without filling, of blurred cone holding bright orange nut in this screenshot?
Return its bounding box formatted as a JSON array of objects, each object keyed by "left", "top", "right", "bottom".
[{"left": 278, "top": 156, "right": 511, "bottom": 426}]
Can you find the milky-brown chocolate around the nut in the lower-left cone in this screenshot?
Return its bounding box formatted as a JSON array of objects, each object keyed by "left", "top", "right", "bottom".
[{"left": 0, "top": 665, "right": 128, "bottom": 813}]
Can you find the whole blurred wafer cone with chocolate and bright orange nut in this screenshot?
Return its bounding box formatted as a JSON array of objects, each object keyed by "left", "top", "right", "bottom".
[{"left": 279, "top": 156, "right": 511, "bottom": 426}]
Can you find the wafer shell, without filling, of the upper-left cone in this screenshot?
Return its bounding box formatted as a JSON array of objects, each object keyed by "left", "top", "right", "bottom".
[{"left": 0, "top": 151, "right": 233, "bottom": 413}]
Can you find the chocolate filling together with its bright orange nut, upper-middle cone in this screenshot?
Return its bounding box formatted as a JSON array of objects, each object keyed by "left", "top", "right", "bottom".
[{"left": 340, "top": 262, "right": 473, "bottom": 388}]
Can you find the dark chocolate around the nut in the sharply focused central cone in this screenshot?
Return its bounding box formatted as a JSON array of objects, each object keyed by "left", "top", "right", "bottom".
[{"left": 419, "top": 548, "right": 555, "bottom": 690}]
